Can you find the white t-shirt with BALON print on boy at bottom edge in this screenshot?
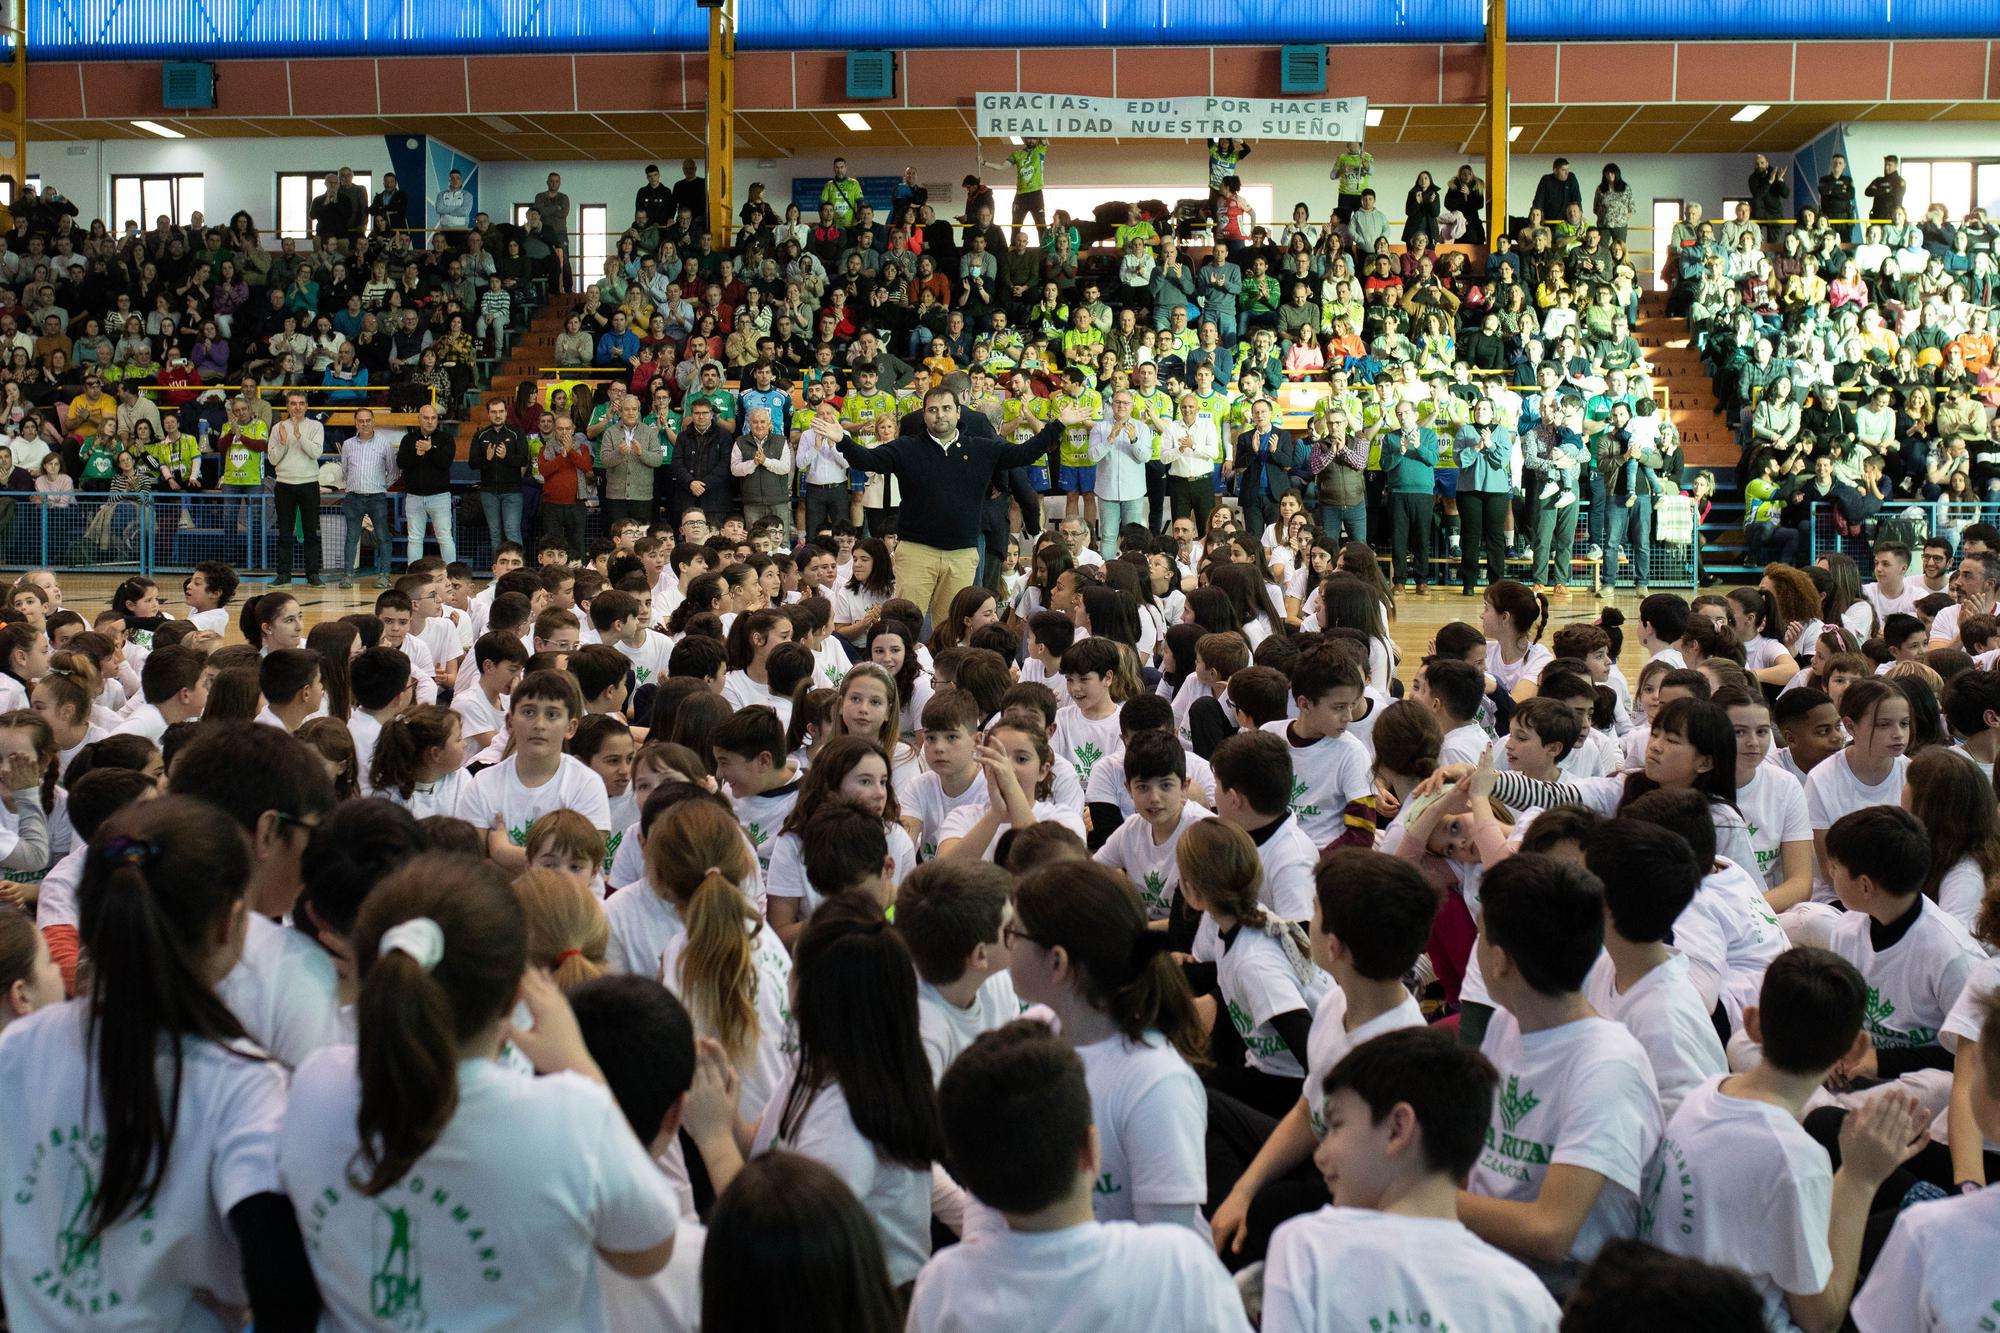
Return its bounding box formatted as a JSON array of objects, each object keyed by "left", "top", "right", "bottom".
[{"left": 1262, "top": 1203, "right": 1562, "bottom": 1333}]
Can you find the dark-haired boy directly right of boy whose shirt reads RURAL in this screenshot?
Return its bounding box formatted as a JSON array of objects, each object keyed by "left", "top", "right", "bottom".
[{"left": 1584, "top": 819, "right": 1728, "bottom": 1119}]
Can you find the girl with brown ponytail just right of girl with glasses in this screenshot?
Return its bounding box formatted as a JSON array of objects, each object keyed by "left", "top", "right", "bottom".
[{"left": 1174, "top": 819, "right": 1332, "bottom": 1119}]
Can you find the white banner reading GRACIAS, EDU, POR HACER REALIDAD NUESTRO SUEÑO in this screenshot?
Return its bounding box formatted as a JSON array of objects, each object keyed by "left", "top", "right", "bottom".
[{"left": 976, "top": 92, "right": 1368, "bottom": 142}]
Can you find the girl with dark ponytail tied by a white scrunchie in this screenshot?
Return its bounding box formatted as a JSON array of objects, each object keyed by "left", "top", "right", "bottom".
[{"left": 274, "top": 853, "right": 678, "bottom": 1329}]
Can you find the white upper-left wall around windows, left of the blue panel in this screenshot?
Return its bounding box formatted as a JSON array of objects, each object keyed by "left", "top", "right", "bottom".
[{"left": 28, "top": 136, "right": 390, "bottom": 232}]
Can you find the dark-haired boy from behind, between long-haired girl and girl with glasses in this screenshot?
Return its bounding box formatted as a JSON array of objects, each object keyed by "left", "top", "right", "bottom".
[{"left": 896, "top": 861, "right": 1020, "bottom": 1081}]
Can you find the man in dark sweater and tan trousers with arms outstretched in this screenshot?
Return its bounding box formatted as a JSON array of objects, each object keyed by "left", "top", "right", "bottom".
[{"left": 812, "top": 388, "right": 1090, "bottom": 624}]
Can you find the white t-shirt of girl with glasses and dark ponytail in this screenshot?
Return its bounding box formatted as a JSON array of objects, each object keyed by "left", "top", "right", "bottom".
[{"left": 1076, "top": 1033, "right": 1208, "bottom": 1233}]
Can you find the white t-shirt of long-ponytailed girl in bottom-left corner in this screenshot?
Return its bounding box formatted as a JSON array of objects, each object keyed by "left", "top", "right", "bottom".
[{"left": 0, "top": 1001, "right": 290, "bottom": 1333}]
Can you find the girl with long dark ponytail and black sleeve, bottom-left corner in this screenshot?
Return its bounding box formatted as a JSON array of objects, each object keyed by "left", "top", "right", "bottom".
[{"left": 0, "top": 797, "right": 320, "bottom": 1329}]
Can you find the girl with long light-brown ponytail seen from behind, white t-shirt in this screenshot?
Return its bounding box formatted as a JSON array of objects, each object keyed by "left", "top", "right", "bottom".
[{"left": 644, "top": 801, "right": 792, "bottom": 1121}]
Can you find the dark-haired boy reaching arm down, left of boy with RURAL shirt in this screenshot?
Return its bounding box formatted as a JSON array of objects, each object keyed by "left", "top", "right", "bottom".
[{"left": 1210, "top": 847, "right": 1440, "bottom": 1263}]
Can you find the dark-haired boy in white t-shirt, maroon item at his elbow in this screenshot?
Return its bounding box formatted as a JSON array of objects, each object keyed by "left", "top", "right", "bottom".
[{"left": 1264, "top": 644, "right": 1374, "bottom": 849}]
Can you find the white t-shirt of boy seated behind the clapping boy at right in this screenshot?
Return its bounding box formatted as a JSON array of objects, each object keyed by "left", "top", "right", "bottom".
[{"left": 1826, "top": 899, "right": 1986, "bottom": 1051}]
